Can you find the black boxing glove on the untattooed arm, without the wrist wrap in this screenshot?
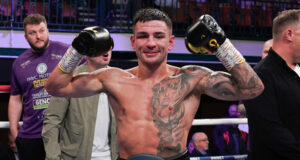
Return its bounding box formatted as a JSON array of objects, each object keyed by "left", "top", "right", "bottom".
[{"left": 72, "top": 26, "right": 114, "bottom": 57}]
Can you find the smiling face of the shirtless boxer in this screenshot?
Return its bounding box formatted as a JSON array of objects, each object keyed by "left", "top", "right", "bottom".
[{"left": 130, "top": 20, "right": 174, "bottom": 65}]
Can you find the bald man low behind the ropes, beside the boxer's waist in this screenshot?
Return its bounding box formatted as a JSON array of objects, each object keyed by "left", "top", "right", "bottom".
[{"left": 190, "top": 132, "right": 209, "bottom": 157}]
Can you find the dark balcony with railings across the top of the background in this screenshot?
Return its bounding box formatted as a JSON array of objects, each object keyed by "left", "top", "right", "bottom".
[{"left": 0, "top": 0, "right": 284, "bottom": 40}]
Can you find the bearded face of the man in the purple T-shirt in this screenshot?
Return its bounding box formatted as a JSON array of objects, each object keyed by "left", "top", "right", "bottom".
[{"left": 25, "top": 22, "right": 49, "bottom": 51}]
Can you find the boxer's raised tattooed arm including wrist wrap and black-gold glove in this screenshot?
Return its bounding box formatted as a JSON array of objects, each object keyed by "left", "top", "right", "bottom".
[{"left": 185, "top": 15, "right": 264, "bottom": 100}]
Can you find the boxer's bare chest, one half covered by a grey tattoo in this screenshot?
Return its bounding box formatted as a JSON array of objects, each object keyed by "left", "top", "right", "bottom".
[{"left": 110, "top": 78, "right": 200, "bottom": 119}]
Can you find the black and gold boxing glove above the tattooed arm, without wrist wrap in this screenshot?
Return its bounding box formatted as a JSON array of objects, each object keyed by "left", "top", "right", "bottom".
[{"left": 185, "top": 14, "right": 226, "bottom": 54}]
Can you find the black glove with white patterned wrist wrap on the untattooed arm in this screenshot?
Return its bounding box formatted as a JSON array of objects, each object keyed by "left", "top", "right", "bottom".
[{"left": 58, "top": 26, "right": 114, "bottom": 73}]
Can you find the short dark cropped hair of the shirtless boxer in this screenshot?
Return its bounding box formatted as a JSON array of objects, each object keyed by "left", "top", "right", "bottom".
[{"left": 133, "top": 8, "right": 173, "bottom": 34}]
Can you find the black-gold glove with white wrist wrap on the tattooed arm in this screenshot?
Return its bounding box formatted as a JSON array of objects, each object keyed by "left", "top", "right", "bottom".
[{"left": 185, "top": 14, "right": 245, "bottom": 71}]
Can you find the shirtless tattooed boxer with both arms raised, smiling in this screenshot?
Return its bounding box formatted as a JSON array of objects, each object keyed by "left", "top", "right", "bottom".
[{"left": 46, "top": 9, "right": 264, "bottom": 160}]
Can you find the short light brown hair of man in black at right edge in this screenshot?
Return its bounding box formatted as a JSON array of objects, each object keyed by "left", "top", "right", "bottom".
[{"left": 272, "top": 9, "right": 300, "bottom": 39}]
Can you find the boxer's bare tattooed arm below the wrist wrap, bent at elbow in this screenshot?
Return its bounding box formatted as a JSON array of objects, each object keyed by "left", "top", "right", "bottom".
[{"left": 198, "top": 63, "right": 264, "bottom": 100}]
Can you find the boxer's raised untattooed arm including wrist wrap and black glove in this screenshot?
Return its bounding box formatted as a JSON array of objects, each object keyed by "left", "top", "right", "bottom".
[{"left": 45, "top": 27, "right": 114, "bottom": 97}]
